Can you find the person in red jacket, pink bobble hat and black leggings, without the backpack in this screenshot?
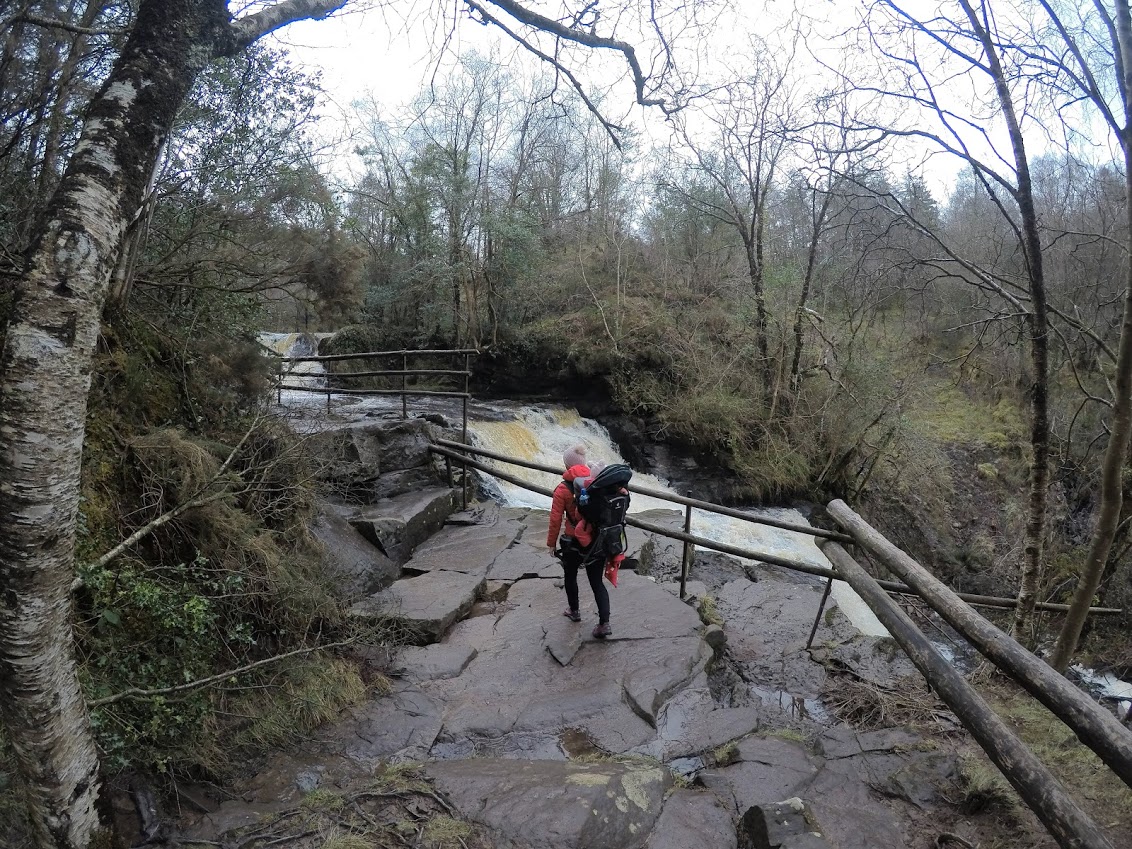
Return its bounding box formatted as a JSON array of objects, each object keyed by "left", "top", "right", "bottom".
[{"left": 547, "top": 445, "right": 612, "bottom": 640}]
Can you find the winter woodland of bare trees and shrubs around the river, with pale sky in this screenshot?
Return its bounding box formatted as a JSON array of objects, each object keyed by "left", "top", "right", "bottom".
[{"left": 0, "top": 0, "right": 1132, "bottom": 849}]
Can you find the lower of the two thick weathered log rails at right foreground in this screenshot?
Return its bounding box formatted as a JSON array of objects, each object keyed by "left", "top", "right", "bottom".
[{"left": 823, "top": 542, "right": 1113, "bottom": 849}]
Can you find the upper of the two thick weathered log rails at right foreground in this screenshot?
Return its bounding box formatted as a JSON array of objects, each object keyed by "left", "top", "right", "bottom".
[{"left": 829, "top": 500, "right": 1132, "bottom": 787}]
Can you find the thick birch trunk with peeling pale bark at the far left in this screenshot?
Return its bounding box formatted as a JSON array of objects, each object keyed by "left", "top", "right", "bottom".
[{"left": 0, "top": 0, "right": 344, "bottom": 849}]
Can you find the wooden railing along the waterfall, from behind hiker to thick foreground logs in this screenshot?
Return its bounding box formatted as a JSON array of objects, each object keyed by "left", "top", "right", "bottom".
[{"left": 430, "top": 439, "right": 1132, "bottom": 849}]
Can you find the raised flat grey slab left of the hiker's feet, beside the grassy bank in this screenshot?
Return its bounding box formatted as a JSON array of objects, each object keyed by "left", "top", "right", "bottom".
[{"left": 350, "top": 571, "right": 484, "bottom": 645}]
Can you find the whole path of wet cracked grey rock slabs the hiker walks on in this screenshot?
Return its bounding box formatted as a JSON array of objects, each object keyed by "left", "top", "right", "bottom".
[{"left": 182, "top": 432, "right": 953, "bottom": 849}]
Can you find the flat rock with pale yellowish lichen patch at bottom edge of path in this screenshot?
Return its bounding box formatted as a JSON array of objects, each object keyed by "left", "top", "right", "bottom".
[{"left": 425, "top": 758, "right": 672, "bottom": 849}]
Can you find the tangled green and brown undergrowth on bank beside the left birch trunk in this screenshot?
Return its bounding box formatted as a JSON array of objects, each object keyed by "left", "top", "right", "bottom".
[{"left": 69, "top": 316, "right": 366, "bottom": 778}]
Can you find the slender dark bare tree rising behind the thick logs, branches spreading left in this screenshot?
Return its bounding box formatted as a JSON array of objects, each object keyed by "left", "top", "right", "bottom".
[{"left": 861, "top": 0, "right": 1049, "bottom": 636}]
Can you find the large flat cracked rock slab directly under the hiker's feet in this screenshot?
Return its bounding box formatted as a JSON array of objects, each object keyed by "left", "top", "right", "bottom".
[{"left": 429, "top": 573, "right": 711, "bottom": 752}]
